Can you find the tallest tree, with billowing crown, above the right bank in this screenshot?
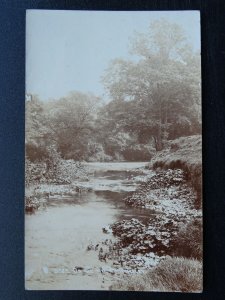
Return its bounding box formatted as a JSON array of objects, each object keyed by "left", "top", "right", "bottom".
[{"left": 103, "top": 19, "right": 201, "bottom": 150}]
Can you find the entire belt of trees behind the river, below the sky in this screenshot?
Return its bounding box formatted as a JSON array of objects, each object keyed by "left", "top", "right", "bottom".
[{"left": 26, "top": 19, "right": 201, "bottom": 169}]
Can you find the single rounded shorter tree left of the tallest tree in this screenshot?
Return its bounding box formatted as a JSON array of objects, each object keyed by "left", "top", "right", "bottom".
[{"left": 48, "top": 92, "right": 99, "bottom": 160}]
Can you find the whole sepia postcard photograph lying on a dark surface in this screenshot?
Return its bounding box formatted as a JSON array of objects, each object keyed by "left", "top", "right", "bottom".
[{"left": 24, "top": 9, "right": 203, "bottom": 293}]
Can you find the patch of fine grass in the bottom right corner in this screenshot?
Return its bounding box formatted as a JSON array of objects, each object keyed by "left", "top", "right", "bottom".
[{"left": 111, "top": 257, "right": 202, "bottom": 292}]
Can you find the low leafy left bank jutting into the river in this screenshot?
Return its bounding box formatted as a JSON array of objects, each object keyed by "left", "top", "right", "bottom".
[{"left": 25, "top": 159, "right": 90, "bottom": 213}]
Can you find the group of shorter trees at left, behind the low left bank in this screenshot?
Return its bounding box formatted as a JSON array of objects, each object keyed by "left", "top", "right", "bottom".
[{"left": 26, "top": 92, "right": 99, "bottom": 162}]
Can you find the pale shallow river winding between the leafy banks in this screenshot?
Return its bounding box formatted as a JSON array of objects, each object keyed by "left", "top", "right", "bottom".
[{"left": 25, "top": 162, "right": 155, "bottom": 290}]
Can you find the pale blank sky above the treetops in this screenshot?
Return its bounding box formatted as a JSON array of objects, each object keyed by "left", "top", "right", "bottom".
[{"left": 26, "top": 10, "right": 200, "bottom": 101}]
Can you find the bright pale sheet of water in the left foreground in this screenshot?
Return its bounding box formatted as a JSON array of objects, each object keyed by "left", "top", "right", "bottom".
[{"left": 25, "top": 195, "right": 118, "bottom": 289}]
